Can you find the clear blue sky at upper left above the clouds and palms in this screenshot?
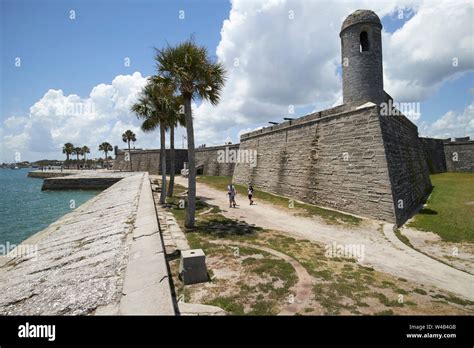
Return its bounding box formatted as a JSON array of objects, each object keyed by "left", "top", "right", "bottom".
[{"left": 1, "top": 0, "right": 230, "bottom": 115}]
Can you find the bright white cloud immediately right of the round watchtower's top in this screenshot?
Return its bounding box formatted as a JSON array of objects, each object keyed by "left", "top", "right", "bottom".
[{"left": 383, "top": 1, "right": 474, "bottom": 102}]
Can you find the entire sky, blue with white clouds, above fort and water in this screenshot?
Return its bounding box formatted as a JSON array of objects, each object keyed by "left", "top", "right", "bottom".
[{"left": 0, "top": 0, "right": 474, "bottom": 162}]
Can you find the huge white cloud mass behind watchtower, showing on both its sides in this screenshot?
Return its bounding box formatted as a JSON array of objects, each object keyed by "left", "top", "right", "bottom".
[{"left": 195, "top": 0, "right": 474, "bottom": 144}]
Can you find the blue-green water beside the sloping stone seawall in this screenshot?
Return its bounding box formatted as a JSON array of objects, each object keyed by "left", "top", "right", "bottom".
[{"left": 0, "top": 168, "right": 100, "bottom": 245}]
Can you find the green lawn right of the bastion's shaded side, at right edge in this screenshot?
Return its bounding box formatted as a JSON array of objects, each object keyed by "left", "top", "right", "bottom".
[{"left": 409, "top": 173, "right": 474, "bottom": 242}]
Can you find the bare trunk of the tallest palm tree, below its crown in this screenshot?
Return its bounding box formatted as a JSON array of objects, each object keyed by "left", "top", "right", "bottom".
[{"left": 184, "top": 98, "right": 196, "bottom": 228}]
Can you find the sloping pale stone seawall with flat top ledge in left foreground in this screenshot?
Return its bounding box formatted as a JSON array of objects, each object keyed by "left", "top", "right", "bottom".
[{"left": 0, "top": 173, "right": 175, "bottom": 315}]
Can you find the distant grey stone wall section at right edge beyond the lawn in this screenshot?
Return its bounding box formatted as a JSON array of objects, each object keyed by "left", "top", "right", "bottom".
[{"left": 444, "top": 137, "right": 474, "bottom": 173}]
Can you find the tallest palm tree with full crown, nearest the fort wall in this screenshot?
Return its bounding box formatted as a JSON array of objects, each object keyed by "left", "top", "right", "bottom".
[{"left": 155, "top": 39, "right": 226, "bottom": 228}]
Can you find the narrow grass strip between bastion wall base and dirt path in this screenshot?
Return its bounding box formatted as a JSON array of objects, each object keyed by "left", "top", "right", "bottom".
[{"left": 197, "top": 176, "right": 362, "bottom": 225}]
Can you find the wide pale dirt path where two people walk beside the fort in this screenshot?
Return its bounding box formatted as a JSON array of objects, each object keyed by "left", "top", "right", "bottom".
[{"left": 175, "top": 177, "right": 474, "bottom": 301}]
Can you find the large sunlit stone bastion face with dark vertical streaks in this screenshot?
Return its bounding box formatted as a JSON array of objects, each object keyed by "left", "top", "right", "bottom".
[{"left": 234, "top": 105, "right": 396, "bottom": 222}]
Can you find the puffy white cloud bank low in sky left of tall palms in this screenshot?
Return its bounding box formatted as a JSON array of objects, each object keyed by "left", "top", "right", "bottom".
[{"left": 2, "top": 72, "right": 158, "bottom": 161}]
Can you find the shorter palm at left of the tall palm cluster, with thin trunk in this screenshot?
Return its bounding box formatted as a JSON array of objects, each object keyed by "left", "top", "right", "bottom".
[{"left": 131, "top": 76, "right": 175, "bottom": 204}]
